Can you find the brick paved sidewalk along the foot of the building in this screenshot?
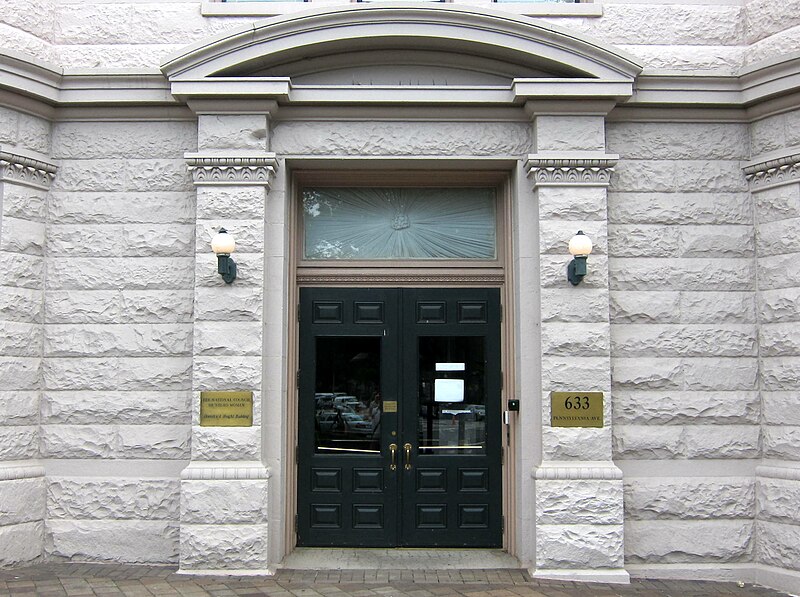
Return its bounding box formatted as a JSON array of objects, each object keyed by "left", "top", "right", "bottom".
[{"left": 0, "top": 564, "right": 785, "bottom": 597}]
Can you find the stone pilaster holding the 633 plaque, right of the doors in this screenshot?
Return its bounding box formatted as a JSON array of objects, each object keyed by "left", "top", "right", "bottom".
[{"left": 526, "top": 110, "right": 629, "bottom": 582}]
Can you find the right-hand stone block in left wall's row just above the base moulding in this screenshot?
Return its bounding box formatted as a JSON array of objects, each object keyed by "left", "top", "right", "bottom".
[{"left": 119, "top": 425, "right": 191, "bottom": 460}]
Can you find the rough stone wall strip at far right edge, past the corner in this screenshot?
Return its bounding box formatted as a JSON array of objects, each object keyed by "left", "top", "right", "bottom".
[{"left": 750, "top": 111, "right": 800, "bottom": 570}]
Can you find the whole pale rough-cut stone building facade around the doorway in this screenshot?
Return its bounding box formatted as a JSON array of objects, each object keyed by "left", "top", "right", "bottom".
[{"left": 0, "top": 0, "right": 800, "bottom": 590}]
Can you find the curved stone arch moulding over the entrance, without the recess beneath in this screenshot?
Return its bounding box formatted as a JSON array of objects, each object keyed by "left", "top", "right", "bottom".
[{"left": 162, "top": 4, "right": 641, "bottom": 82}]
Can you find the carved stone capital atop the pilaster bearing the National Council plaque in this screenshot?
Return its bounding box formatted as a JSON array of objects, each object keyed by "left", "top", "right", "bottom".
[{"left": 185, "top": 153, "right": 278, "bottom": 188}]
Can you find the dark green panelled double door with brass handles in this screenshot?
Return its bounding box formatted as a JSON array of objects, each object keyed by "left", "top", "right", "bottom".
[{"left": 297, "top": 288, "right": 502, "bottom": 547}]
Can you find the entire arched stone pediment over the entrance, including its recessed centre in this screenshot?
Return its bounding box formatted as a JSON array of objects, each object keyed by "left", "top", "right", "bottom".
[{"left": 162, "top": 3, "right": 641, "bottom": 85}]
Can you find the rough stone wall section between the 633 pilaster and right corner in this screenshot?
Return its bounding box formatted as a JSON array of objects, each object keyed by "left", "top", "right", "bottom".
[{"left": 608, "top": 122, "right": 761, "bottom": 565}]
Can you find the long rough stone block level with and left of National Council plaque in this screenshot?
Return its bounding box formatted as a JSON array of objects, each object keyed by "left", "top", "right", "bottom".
[{"left": 41, "top": 390, "right": 191, "bottom": 425}]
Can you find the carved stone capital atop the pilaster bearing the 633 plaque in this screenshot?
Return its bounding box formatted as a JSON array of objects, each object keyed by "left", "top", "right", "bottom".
[{"left": 525, "top": 154, "right": 619, "bottom": 187}]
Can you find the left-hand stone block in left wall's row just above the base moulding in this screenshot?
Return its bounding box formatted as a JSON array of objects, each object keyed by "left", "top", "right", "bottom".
[{"left": 40, "top": 425, "right": 119, "bottom": 458}]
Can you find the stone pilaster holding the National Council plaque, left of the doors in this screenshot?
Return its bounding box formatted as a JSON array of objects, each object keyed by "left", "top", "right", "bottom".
[{"left": 180, "top": 114, "right": 276, "bottom": 574}]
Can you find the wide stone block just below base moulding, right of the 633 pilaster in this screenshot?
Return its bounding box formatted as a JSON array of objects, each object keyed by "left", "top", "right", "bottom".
[{"left": 625, "top": 477, "right": 756, "bottom": 520}]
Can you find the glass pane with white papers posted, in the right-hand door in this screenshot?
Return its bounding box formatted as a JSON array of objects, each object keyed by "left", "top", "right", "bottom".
[{"left": 418, "top": 336, "right": 486, "bottom": 454}]
